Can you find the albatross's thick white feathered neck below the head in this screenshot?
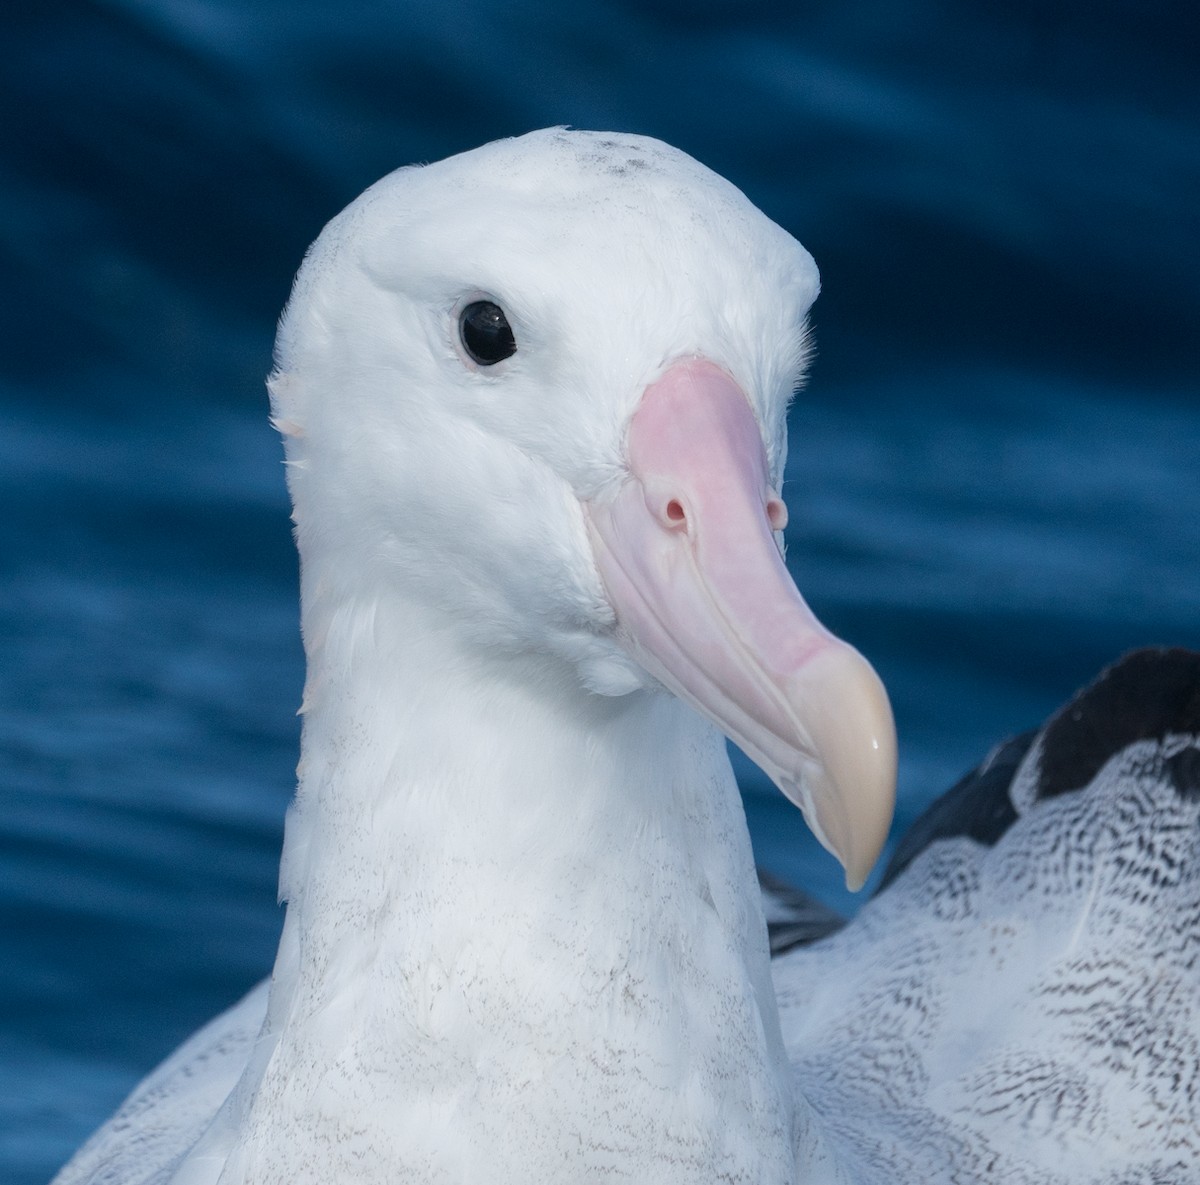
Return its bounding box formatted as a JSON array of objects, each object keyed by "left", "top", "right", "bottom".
[{"left": 211, "top": 587, "right": 794, "bottom": 1185}]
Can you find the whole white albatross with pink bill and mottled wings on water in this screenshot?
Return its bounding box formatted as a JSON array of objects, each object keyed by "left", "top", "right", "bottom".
[{"left": 56, "top": 128, "right": 1200, "bottom": 1185}]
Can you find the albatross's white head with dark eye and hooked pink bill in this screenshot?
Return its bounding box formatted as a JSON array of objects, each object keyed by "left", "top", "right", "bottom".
[{"left": 271, "top": 130, "right": 895, "bottom": 886}]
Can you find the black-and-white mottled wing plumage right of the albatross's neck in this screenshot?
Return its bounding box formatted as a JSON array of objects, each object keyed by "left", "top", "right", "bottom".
[{"left": 774, "top": 650, "right": 1200, "bottom": 1185}]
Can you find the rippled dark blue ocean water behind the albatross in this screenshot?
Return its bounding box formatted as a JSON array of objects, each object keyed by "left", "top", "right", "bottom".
[{"left": 0, "top": 0, "right": 1200, "bottom": 1185}]
